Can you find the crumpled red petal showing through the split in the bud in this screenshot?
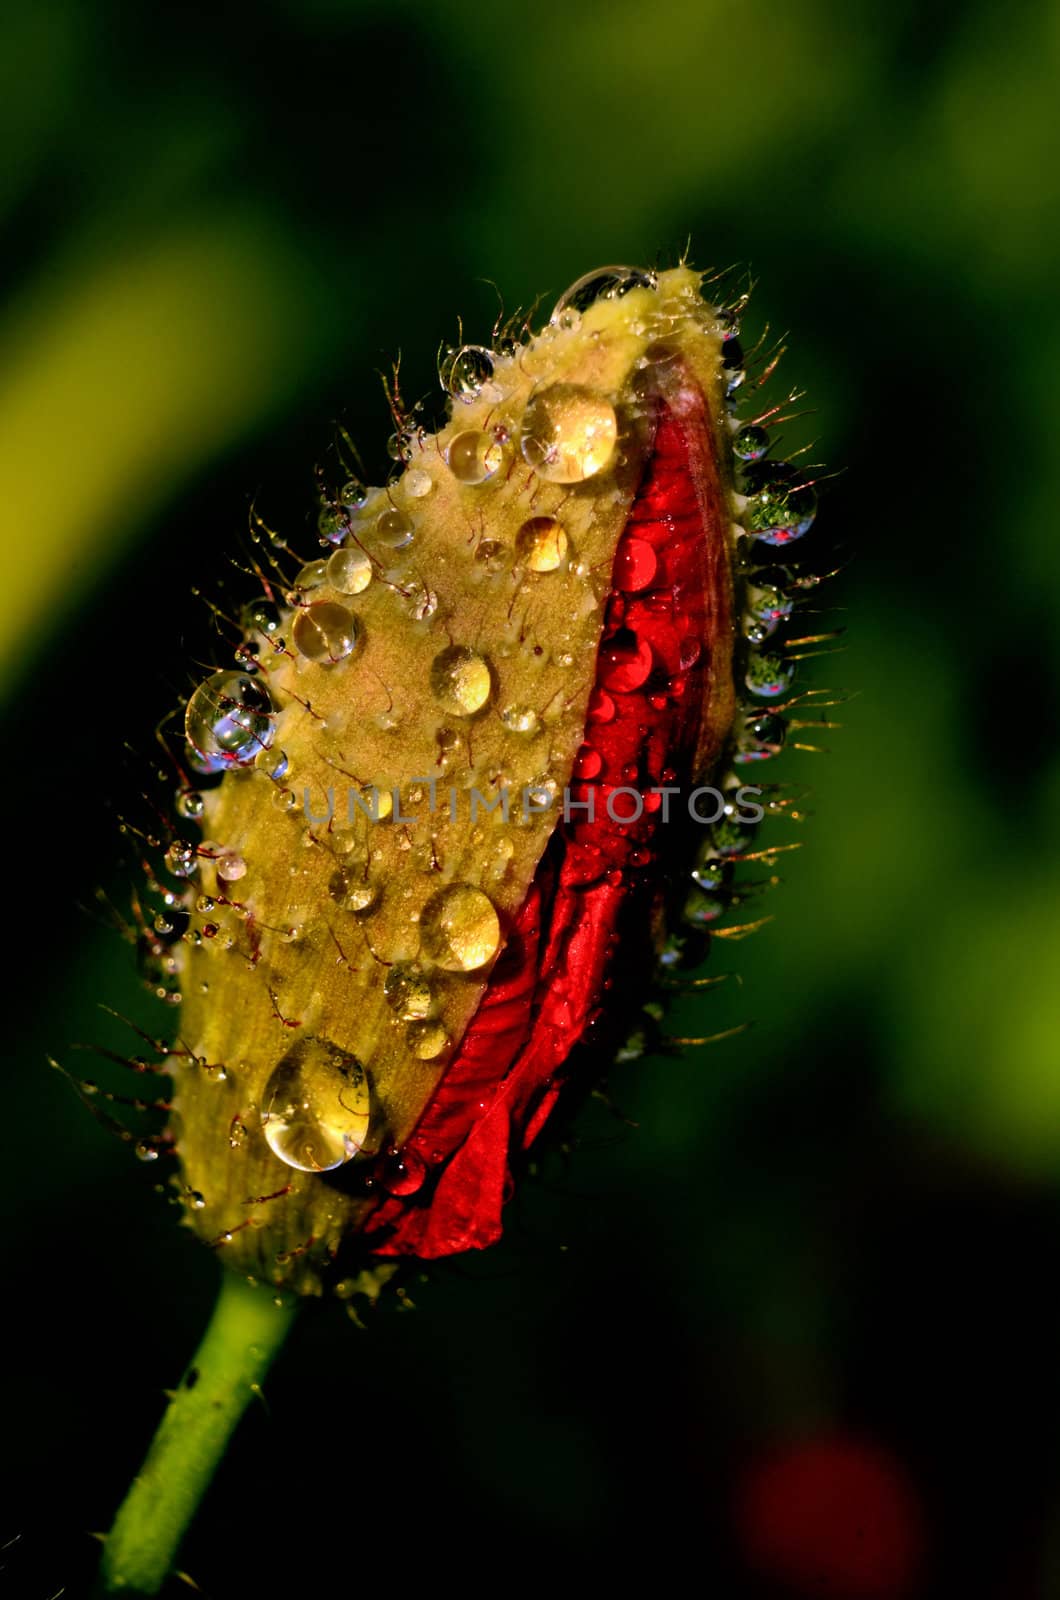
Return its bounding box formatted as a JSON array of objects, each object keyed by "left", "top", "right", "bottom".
[{"left": 367, "top": 373, "right": 732, "bottom": 1258}]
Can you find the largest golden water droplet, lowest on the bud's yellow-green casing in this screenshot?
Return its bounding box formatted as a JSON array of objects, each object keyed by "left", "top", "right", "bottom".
[{"left": 261, "top": 1038, "right": 371, "bottom": 1173}]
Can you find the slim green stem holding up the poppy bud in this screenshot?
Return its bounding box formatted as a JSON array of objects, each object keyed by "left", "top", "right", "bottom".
[{"left": 101, "top": 1272, "right": 296, "bottom": 1595}]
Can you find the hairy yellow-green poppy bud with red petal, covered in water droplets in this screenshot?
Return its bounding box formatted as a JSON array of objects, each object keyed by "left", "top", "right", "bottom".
[{"left": 170, "top": 266, "right": 813, "bottom": 1293}]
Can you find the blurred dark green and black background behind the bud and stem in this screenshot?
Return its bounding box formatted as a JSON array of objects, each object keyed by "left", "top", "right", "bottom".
[{"left": 0, "top": 0, "right": 1060, "bottom": 1600}]
